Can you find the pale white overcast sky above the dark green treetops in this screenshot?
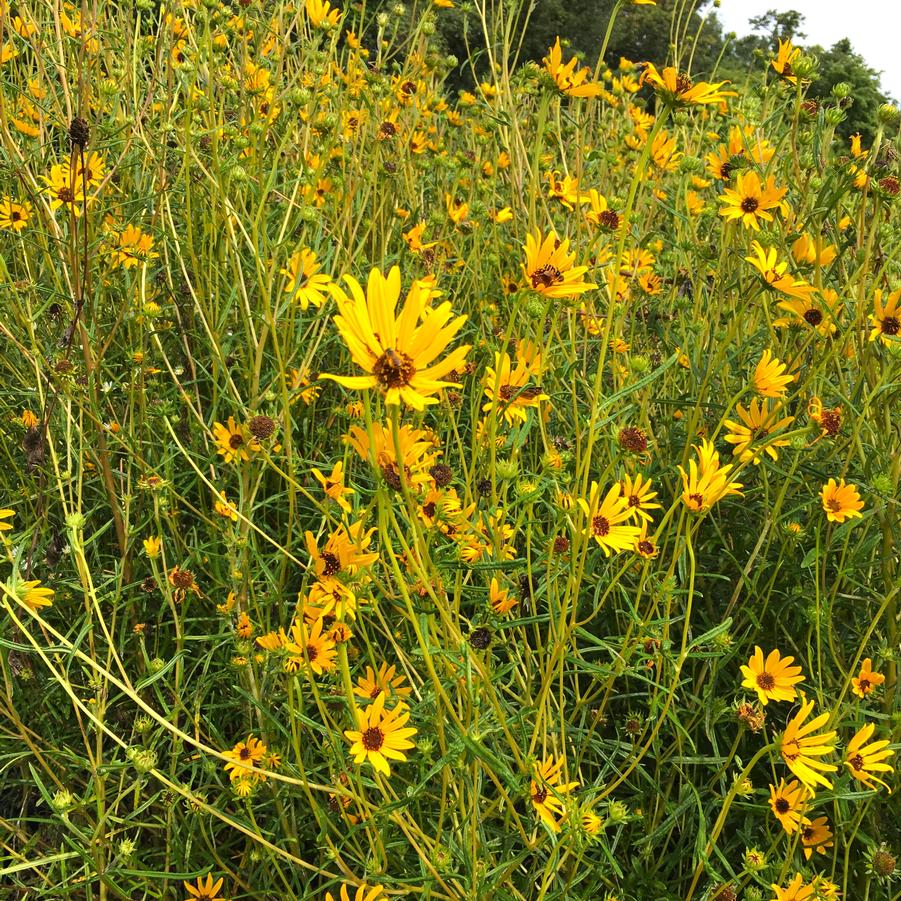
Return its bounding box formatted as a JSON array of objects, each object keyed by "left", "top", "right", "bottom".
[{"left": 716, "top": 0, "right": 901, "bottom": 100}]
